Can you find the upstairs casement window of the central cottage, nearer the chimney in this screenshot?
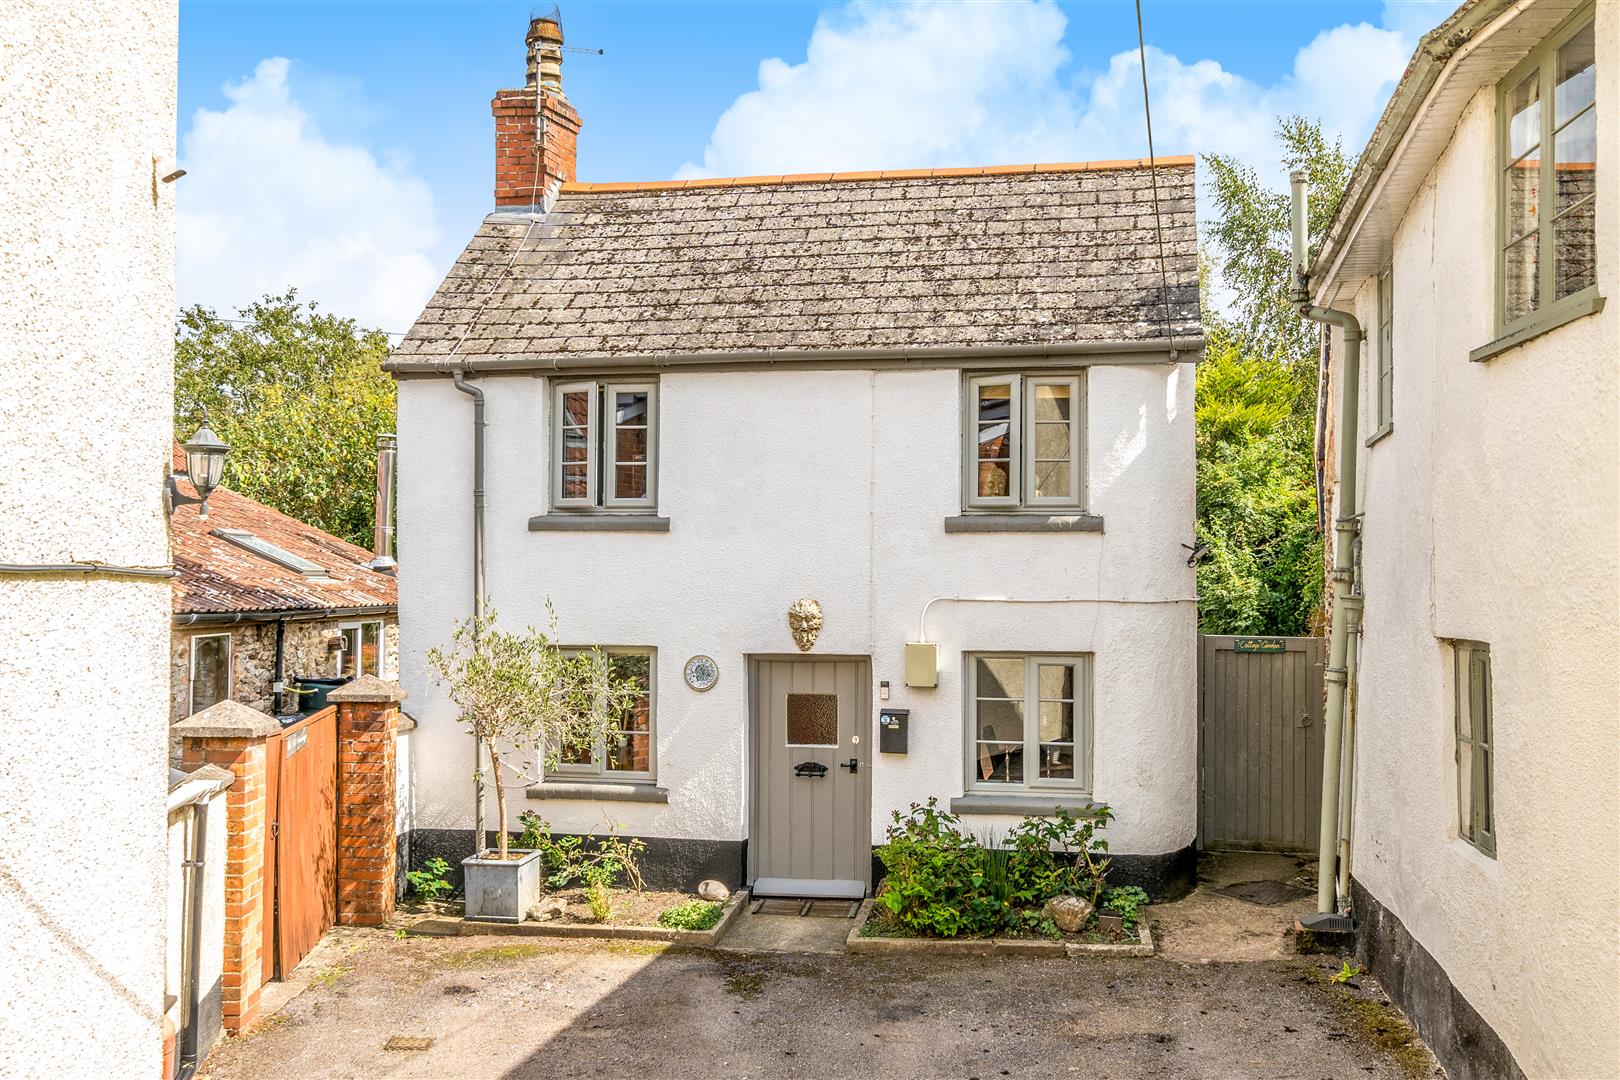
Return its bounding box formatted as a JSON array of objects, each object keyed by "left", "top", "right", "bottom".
[{"left": 551, "top": 382, "right": 658, "bottom": 510}]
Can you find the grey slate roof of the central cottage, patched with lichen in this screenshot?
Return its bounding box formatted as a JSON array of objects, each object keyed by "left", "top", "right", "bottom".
[{"left": 389, "top": 157, "right": 1200, "bottom": 371}]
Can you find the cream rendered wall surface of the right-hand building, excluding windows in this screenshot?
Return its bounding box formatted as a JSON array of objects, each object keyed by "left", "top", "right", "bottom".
[{"left": 1335, "top": 12, "right": 1620, "bottom": 1077}]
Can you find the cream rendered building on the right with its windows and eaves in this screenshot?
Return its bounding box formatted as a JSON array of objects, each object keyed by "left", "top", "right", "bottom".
[{"left": 1311, "top": 0, "right": 1620, "bottom": 1078}]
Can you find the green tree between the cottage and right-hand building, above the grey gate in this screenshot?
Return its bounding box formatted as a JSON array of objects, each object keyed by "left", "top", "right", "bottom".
[{"left": 1196, "top": 117, "right": 1349, "bottom": 635}]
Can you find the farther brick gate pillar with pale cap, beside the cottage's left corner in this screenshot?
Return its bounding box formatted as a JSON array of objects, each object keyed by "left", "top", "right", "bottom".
[{"left": 326, "top": 675, "right": 405, "bottom": 926}]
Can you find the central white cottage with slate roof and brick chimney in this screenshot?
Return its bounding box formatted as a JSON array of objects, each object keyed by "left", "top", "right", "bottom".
[{"left": 389, "top": 19, "right": 1202, "bottom": 894}]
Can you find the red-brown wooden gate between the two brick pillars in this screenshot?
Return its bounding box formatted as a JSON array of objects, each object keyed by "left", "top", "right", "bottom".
[{"left": 262, "top": 706, "right": 337, "bottom": 981}]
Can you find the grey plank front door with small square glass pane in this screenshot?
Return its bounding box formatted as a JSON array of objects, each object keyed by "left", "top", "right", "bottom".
[{"left": 748, "top": 659, "right": 872, "bottom": 897}]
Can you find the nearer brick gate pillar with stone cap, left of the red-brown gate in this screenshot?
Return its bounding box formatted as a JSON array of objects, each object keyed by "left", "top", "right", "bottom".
[{"left": 172, "top": 701, "right": 282, "bottom": 1035}]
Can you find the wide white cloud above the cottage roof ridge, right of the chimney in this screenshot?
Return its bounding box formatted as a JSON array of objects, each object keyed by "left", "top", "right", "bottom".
[{"left": 676, "top": 0, "right": 1443, "bottom": 191}]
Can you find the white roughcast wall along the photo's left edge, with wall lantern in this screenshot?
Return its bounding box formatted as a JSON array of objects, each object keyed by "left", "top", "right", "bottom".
[{"left": 0, "top": 0, "right": 177, "bottom": 1077}]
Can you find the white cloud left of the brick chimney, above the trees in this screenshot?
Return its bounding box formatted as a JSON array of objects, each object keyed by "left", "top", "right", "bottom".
[{"left": 177, "top": 57, "right": 441, "bottom": 330}]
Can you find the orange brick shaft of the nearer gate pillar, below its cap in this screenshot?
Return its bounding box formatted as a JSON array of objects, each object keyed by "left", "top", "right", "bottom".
[{"left": 181, "top": 735, "right": 269, "bottom": 1035}]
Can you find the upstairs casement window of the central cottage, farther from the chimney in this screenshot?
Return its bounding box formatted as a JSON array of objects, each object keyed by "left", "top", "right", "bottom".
[{"left": 964, "top": 374, "right": 1085, "bottom": 510}]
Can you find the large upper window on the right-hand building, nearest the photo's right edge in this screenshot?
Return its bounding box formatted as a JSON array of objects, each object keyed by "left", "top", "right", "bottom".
[{"left": 1495, "top": 3, "right": 1599, "bottom": 337}]
